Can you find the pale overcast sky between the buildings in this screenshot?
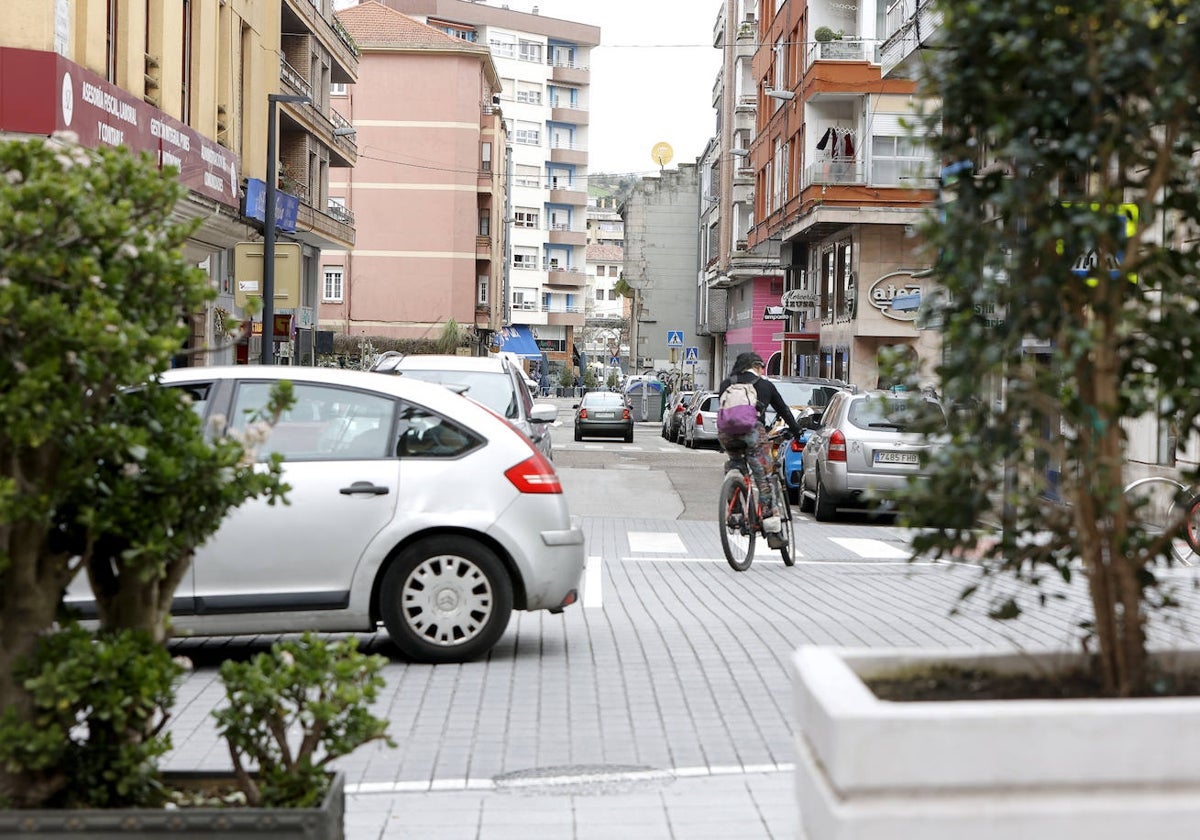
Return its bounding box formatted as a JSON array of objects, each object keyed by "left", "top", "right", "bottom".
[{"left": 335, "top": 0, "right": 722, "bottom": 174}]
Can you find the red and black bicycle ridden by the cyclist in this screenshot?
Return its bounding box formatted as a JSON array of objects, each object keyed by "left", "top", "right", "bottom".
[{"left": 718, "top": 434, "right": 796, "bottom": 571}]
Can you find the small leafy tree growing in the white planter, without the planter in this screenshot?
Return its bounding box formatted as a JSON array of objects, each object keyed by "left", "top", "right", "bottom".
[{"left": 906, "top": 0, "right": 1200, "bottom": 696}]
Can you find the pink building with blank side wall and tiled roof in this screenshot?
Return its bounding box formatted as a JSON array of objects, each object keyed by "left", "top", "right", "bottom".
[{"left": 320, "top": 0, "right": 506, "bottom": 354}]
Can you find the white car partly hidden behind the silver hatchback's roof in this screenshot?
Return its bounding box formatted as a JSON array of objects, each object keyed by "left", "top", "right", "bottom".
[{"left": 371, "top": 350, "right": 558, "bottom": 458}]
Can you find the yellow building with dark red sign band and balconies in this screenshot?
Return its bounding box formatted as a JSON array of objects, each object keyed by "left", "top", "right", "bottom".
[{"left": 0, "top": 0, "right": 358, "bottom": 364}]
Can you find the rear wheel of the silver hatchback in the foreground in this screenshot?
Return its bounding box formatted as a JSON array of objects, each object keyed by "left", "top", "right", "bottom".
[{"left": 379, "top": 536, "right": 512, "bottom": 664}]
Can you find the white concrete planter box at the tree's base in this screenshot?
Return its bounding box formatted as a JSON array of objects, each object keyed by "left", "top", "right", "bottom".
[{"left": 792, "top": 647, "right": 1200, "bottom": 840}]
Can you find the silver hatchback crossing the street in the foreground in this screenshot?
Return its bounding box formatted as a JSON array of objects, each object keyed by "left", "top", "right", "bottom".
[{"left": 66, "top": 365, "right": 584, "bottom": 662}]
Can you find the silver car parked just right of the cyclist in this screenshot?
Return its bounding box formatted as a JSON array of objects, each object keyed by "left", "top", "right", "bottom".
[{"left": 800, "top": 391, "right": 946, "bottom": 521}]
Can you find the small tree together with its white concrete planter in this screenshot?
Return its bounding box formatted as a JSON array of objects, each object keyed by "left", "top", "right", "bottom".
[{"left": 796, "top": 0, "right": 1200, "bottom": 839}]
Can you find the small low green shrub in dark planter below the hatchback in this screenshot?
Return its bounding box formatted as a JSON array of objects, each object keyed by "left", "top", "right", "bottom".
[{"left": 212, "top": 634, "right": 395, "bottom": 808}]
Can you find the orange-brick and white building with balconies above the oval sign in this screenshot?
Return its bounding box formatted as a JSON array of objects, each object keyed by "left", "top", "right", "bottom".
[{"left": 726, "top": 0, "right": 940, "bottom": 388}]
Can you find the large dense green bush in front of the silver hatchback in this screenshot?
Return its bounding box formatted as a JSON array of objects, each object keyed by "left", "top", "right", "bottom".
[{"left": 0, "top": 137, "right": 388, "bottom": 830}]
